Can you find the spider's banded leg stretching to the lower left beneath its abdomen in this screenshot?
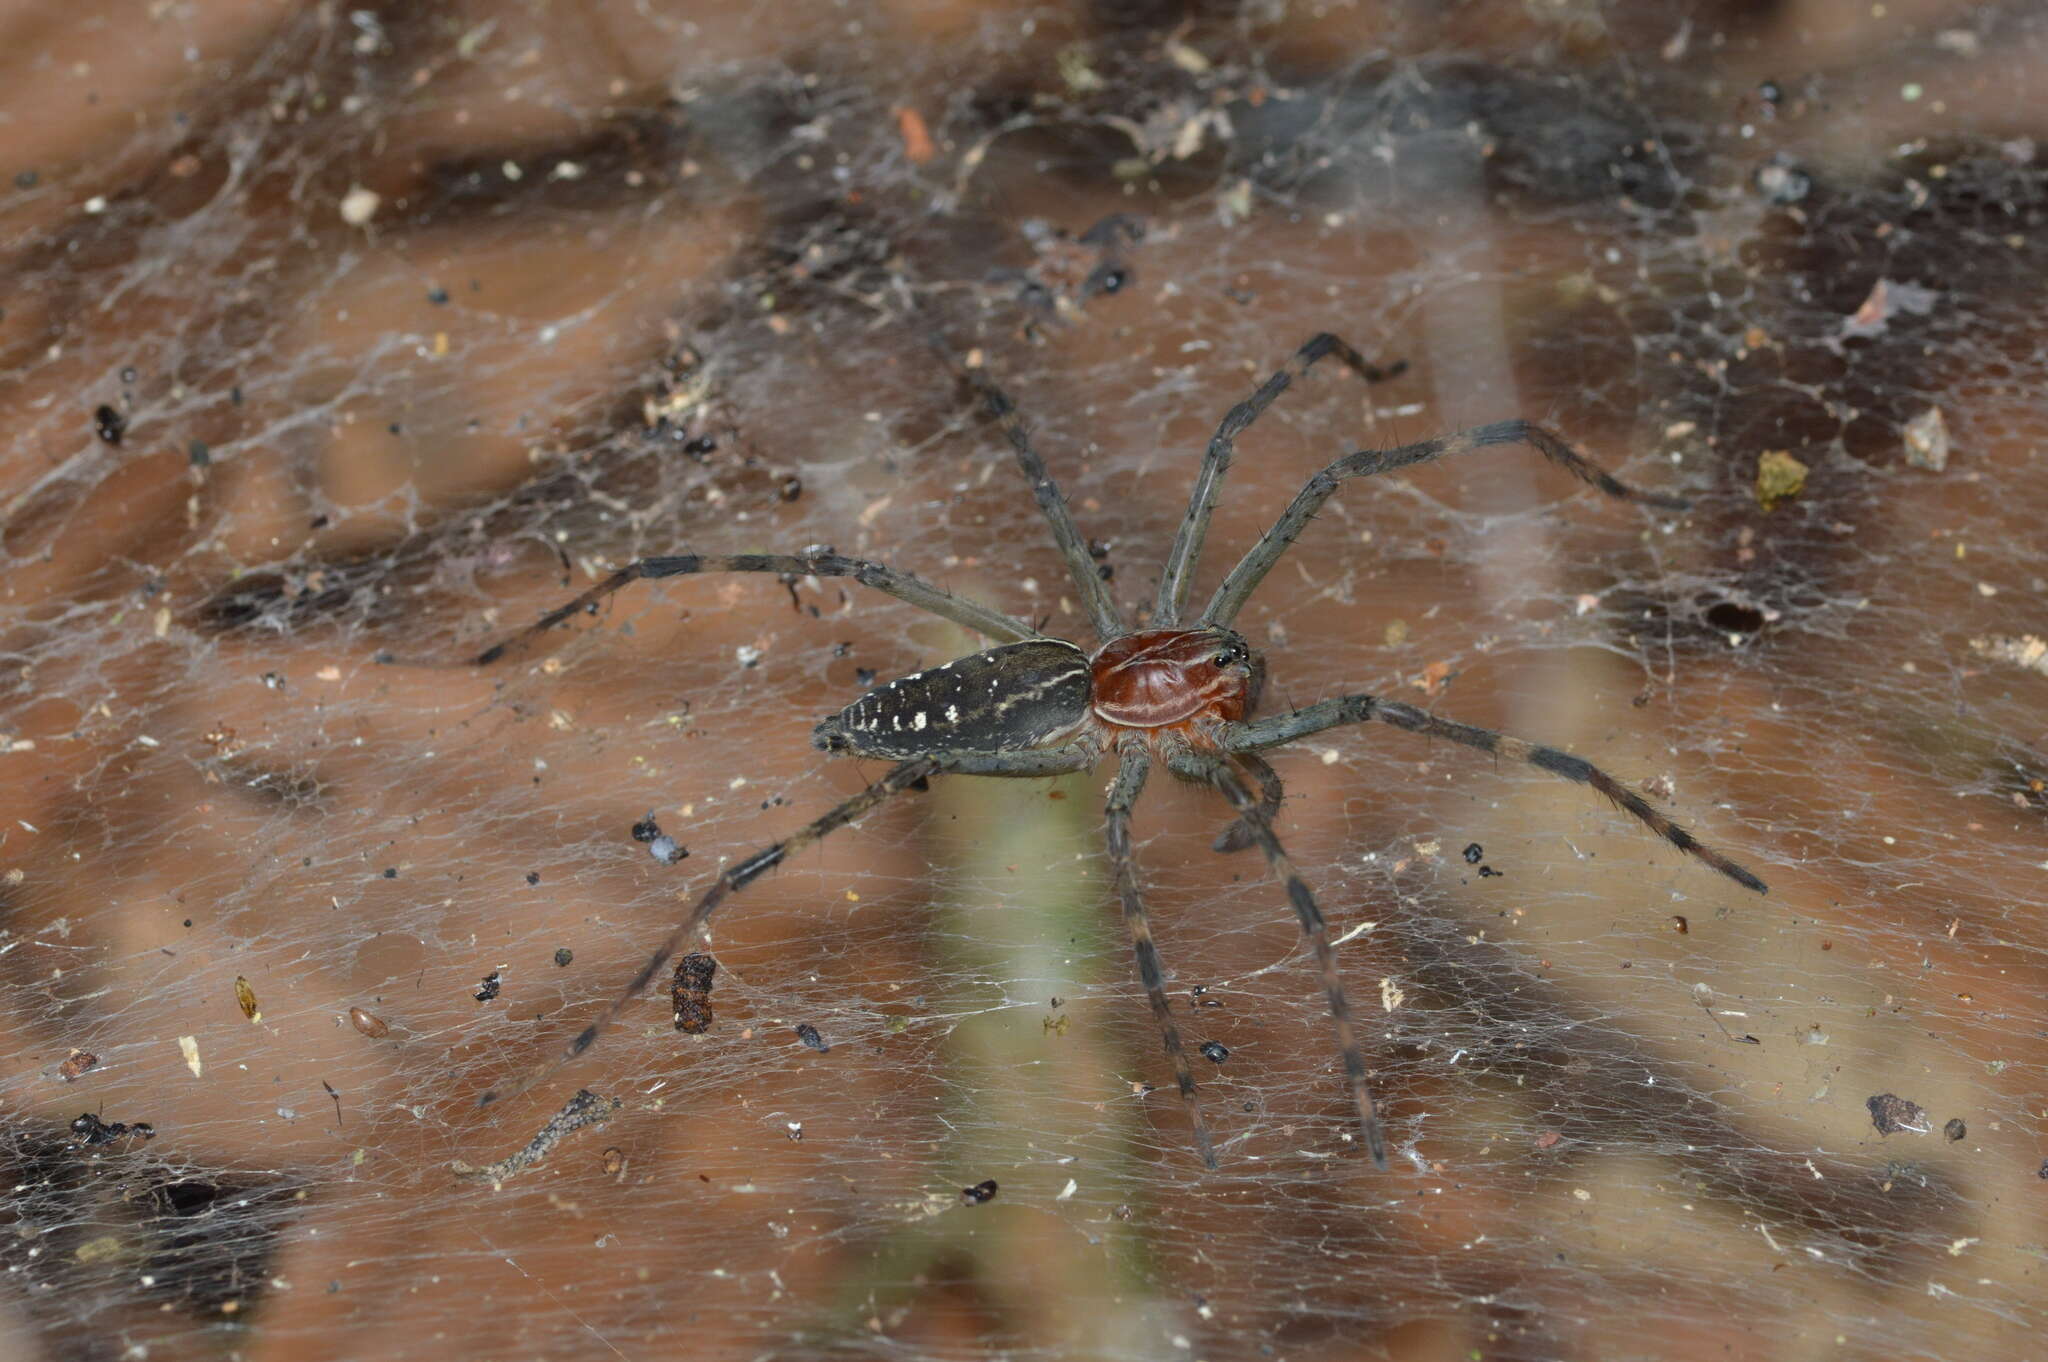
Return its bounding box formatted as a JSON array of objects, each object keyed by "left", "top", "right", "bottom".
[{"left": 477, "top": 746, "right": 1096, "bottom": 1106}]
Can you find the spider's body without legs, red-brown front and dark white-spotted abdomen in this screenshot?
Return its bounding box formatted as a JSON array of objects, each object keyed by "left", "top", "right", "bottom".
[{"left": 811, "top": 629, "right": 1264, "bottom": 760}]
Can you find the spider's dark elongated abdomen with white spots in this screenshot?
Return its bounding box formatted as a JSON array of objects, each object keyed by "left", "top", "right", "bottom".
[{"left": 811, "top": 639, "right": 1094, "bottom": 760}]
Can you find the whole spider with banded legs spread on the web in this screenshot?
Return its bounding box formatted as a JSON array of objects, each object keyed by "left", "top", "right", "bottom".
[{"left": 477, "top": 334, "right": 1765, "bottom": 1167}]
